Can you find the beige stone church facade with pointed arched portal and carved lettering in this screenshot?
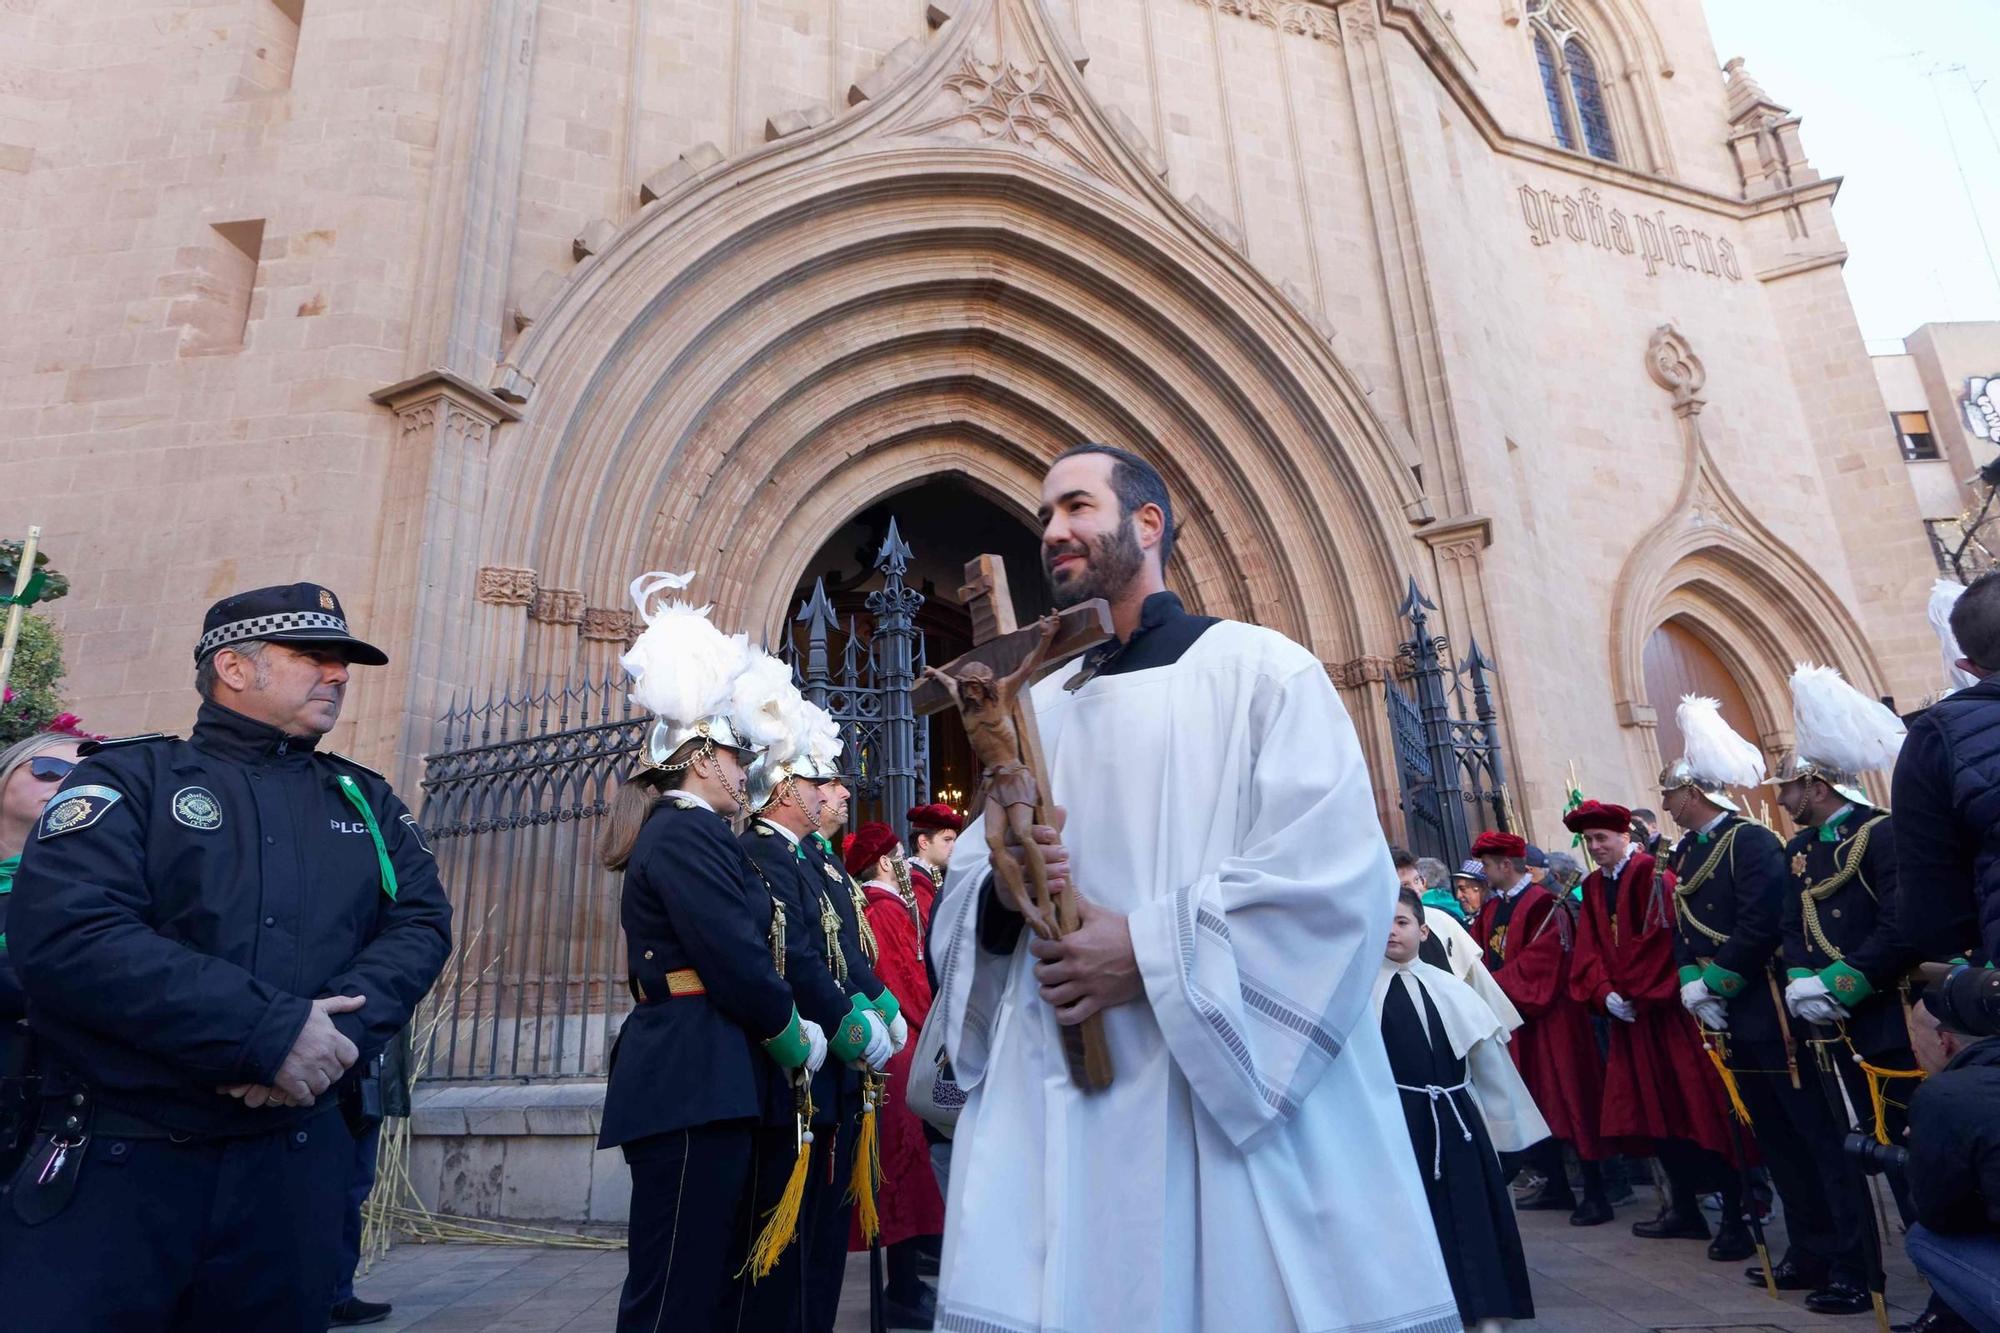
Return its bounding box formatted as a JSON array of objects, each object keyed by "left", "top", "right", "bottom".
[{"left": 0, "top": 0, "right": 1938, "bottom": 841}]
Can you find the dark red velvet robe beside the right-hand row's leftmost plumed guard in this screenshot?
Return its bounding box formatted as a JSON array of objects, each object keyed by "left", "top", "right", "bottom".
[{"left": 1570, "top": 853, "right": 1736, "bottom": 1161}]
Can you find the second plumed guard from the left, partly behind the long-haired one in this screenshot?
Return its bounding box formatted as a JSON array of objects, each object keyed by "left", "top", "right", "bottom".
[{"left": 742, "top": 691, "right": 894, "bottom": 1333}]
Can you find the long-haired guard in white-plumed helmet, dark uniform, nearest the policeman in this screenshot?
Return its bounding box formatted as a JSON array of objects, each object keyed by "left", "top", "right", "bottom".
[{"left": 598, "top": 574, "right": 826, "bottom": 1333}]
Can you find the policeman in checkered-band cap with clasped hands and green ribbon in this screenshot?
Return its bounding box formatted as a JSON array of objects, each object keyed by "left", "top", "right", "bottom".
[{"left": 0, "top": 582, "right": 452, "bottom": 1333}]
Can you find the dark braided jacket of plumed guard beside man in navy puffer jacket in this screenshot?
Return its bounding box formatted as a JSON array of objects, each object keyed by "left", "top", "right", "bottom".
[{"left": 1784, "top": 805, "right": 1918, "bottom": 1055}]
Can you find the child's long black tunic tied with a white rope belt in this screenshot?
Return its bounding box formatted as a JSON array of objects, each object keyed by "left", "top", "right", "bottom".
[{"left": 1382, "top": 971, "right": 1534, "bottom": 1327}]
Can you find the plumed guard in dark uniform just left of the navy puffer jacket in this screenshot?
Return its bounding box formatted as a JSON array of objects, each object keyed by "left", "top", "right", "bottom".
[{"left": 1772, "top": 667, "right": 1918, "bottom": 1315}]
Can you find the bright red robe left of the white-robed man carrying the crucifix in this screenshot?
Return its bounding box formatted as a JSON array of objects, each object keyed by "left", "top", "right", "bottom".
[{"left": 848, "top": 875, "right": 944, "bottom": 1249}]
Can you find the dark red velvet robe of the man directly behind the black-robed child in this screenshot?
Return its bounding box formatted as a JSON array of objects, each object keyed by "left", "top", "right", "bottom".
[{"left": 1470, "top": 885, "right": 1612, "bottom": 1161}]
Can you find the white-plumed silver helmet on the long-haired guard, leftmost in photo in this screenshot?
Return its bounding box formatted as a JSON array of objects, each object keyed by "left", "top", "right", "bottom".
[{"left": 618, "top": 570, "right": 756, "bottom": 769}]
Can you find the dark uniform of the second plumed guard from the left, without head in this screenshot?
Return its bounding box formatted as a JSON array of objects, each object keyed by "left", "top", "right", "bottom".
[{"left": 740, "top": 819, "right": 862, "bottom": 1333}]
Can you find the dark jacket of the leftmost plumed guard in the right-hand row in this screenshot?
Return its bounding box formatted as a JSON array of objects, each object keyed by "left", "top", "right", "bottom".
[{"left": 1670, "top": 815, "right": 1788, "bottom": 1045}]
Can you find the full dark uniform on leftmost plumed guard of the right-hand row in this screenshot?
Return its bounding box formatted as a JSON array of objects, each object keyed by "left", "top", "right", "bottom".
[{"left": 1672, "top": 815, "right": 1860, "bottom": 1279}]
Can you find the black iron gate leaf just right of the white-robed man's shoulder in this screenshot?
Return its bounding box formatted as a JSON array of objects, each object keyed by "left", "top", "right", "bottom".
[{"left": 1384, "top": 578, "right": 1520, "bottom": 869}]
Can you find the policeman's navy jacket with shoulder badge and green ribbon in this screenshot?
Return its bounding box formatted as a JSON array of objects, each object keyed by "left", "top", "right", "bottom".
[{"left": 8, "top": 703, "right": 452, "bottom": 1135}]
